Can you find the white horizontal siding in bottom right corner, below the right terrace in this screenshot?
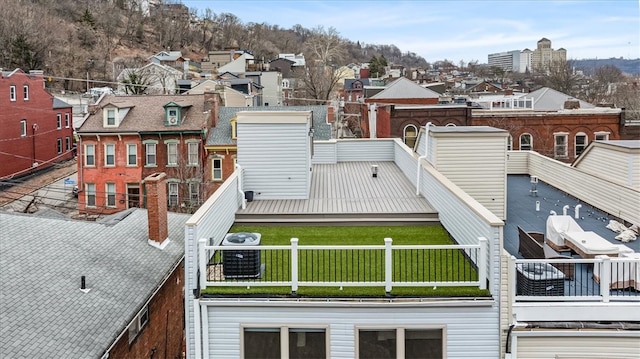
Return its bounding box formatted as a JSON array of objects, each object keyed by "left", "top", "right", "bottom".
[{"left": 514, "top": 330, "right": 640, "bottom": 359}]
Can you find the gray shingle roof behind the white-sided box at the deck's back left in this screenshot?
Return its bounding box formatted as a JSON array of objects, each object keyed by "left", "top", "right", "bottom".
[{"left": 206, "top": 105, "right": 331, "bottom": 146}]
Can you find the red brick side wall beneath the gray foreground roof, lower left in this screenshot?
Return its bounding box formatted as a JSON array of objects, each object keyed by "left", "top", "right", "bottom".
[{"left": 109, "top": 265, "right": 184, "bottom": 359}]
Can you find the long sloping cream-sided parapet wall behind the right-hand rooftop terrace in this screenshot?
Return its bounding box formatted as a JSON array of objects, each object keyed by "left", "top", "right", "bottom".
[{"left": 529, "top": 152, "right": 640, "bottom": 223}]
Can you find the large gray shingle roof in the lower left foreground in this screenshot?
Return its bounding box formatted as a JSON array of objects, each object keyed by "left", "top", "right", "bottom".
[{"left": 0, "top": 209, "right": 189, "bottom": 358}]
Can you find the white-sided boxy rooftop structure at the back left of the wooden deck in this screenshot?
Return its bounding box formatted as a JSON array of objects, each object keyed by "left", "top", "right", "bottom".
[{"left": 238, "top": 121, "right": 311, "bottom": 200}]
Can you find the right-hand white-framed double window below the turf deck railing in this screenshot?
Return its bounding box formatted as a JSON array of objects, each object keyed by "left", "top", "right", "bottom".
[{"left": 356, "top": 327, "right": 446, "bottom": 359}]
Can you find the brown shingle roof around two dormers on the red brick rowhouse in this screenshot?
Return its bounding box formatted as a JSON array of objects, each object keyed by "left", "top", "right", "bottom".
[{"left": 77, "top": 95, "right": 208, "bottom": 134}]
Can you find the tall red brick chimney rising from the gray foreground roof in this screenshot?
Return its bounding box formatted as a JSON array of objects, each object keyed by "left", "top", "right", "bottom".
[{"left": 144, "top": 172, "right": 169, "bottom": 249}]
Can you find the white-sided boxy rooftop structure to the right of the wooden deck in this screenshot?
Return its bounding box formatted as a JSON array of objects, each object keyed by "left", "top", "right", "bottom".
[{"left": 429, "top": 132, "right": 507, "bottom": 219}]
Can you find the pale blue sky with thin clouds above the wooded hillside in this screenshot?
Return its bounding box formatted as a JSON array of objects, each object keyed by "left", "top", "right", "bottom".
[{"left": 182, "top": 0, "right": 640, "bottom": 63}]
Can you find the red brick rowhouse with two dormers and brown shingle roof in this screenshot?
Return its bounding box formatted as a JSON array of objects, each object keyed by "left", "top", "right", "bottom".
[{"left": 77, "top": 94, "right": 210, "bottom": 213}]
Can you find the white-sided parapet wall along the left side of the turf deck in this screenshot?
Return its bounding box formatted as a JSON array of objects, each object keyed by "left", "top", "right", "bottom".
[{"left": 184, "top": 176, "right": 243, "bottom": 358}]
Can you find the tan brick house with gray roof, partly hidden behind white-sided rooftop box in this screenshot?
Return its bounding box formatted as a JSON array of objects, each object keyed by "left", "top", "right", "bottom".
[{"left": 205, "top": 105, "right": 331, "bottom": 197}]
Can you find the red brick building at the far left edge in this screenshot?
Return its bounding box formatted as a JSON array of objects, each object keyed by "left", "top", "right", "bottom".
[{"left": 0, "top": 69, "right": 74, "bottom": 180}]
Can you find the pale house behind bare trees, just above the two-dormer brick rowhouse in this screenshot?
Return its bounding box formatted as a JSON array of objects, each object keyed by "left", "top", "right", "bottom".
[{"left": 116, "top": 62, "right": 183, "bottom": 95}]
